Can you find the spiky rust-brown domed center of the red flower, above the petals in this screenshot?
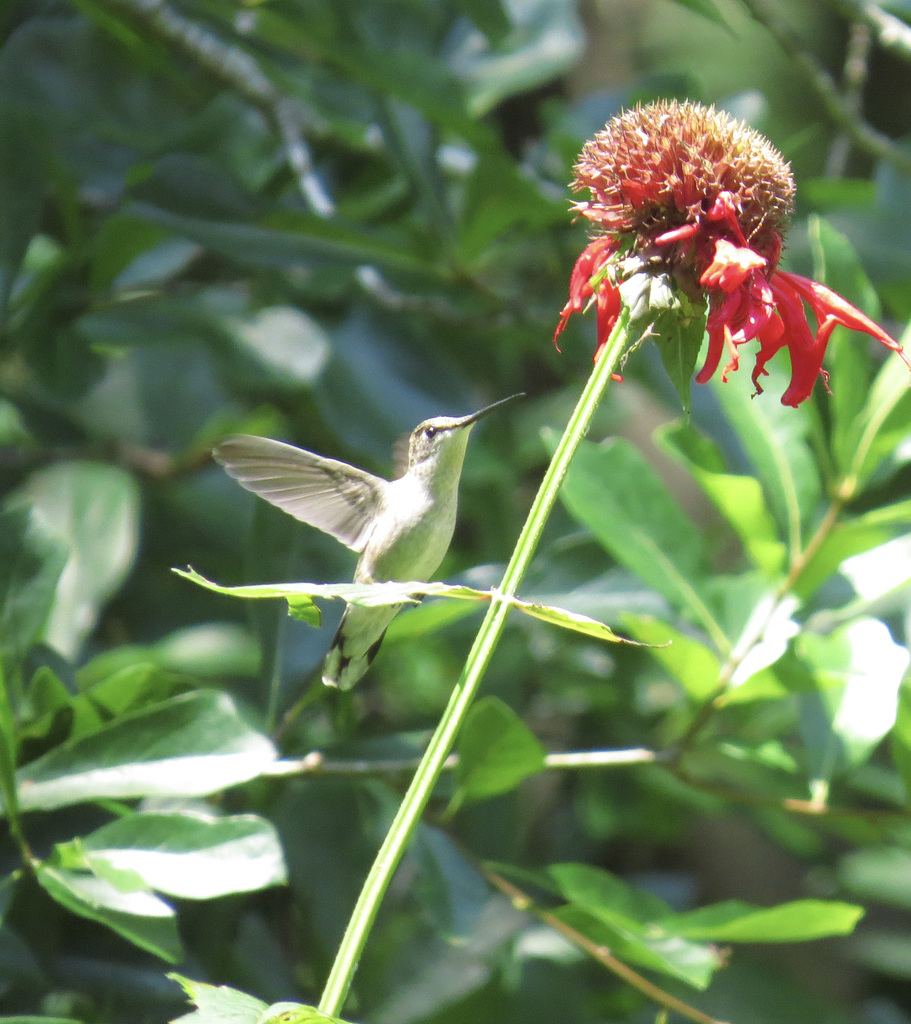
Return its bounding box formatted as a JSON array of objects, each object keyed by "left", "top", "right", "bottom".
[{"left": 572, "top": 100, "right": 794, "bottom": 262}]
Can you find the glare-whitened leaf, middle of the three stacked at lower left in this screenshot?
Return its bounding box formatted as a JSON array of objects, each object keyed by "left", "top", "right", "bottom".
[{"left": 82, "top": 812, "right": 288, "bottom": 899}]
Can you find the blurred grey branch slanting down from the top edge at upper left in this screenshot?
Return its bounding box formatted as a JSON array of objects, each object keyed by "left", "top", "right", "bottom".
[{"left": 101, "top": 0, "right": 335, "bottom": 217}]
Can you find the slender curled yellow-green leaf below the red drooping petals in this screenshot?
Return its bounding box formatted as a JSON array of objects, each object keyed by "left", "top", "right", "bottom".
[{"left": 655, "top": 423, "right": 787, "bottom": 575}]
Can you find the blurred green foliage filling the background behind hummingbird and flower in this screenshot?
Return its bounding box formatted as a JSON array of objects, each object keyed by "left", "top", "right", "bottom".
[{"left": 0, "top": 0, "right": 911, "bottom": 1024}]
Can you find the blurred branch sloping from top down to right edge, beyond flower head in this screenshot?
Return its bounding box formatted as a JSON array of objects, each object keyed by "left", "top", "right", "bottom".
[{"left": 741, "top": 0, "right": 911, "bottom": 174}]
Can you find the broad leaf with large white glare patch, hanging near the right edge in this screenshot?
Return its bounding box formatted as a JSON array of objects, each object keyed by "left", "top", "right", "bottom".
[{"left": 796, "top": 618, "right": 911, "bottom": 782}]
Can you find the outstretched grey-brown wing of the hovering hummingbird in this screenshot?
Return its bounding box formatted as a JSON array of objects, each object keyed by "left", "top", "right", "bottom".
[{"left": 212, "top": 434, "right": 387, "bottom": 552}]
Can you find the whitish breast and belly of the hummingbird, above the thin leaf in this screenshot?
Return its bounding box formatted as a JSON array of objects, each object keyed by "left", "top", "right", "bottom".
[{"left": 355, "top": 474, "right": 458, "bottom": 582}]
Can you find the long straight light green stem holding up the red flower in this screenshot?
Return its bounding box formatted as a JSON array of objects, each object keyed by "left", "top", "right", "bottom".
[{"left": 319, "top": 313, "right": 630, "bottom": 1017}]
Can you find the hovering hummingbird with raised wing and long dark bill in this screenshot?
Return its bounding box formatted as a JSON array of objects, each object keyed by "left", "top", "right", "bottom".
[{"left": 212, "top": 394, "right": 524, "bottom": 690}]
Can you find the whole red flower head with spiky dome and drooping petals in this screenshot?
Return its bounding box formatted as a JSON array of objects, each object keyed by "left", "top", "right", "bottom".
[{"left": 554, "top": 100, "right": 911, "bottom": 406}]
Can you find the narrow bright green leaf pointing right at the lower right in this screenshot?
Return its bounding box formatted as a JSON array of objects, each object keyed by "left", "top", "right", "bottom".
[{"left": 662, "top": 899, "right": 864, "bottom": 942}]
